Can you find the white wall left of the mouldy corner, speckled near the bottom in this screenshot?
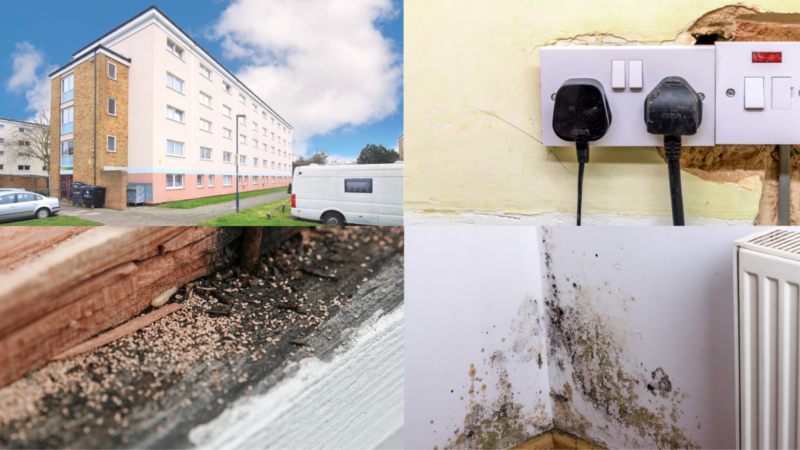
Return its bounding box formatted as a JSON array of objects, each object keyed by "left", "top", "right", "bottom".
[{"left": 405, "top": 227, "right": 552, "bottom": 449}]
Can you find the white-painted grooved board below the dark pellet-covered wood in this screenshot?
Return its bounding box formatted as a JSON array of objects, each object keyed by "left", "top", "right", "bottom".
[{"left": 189, "top": 304, "right": 404, "bottom": 449}]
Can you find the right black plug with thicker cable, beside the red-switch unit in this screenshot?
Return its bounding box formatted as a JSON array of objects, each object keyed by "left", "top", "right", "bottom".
[{"left": 644, "top": 77, "right": 703, "bottom": 225}]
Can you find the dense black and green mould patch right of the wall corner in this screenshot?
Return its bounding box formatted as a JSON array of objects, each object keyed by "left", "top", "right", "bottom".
[{"left": 543, "top": 230, "right": 700, "bottom": 448}]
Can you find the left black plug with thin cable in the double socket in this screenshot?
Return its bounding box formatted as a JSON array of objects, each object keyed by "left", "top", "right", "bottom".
[{"left": 553, "top": 78, "right": 611, "bottom": 226}]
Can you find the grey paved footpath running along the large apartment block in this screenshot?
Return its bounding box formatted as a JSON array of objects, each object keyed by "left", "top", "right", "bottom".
[{"left": 58, "top": 192, "right": 289, "bottom": 226}]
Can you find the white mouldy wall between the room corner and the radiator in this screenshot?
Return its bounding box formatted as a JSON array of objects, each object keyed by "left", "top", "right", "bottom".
[{"left": 540, "top": 227, "right": 753, "bottom": 448}]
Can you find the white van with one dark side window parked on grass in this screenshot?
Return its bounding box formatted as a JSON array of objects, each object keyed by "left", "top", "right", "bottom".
[{"left": 291, "top": 161, "right": 403, "bottom": 225}]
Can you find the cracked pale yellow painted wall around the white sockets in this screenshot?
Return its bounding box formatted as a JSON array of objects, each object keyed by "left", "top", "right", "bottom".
[{"left": 405, "top": 0, "right": 800, "bottom": 219}]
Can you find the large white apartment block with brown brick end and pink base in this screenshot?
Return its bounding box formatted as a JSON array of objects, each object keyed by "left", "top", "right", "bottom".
[{"left": 50, "top": 7, "right": 293, "bottom": 209}]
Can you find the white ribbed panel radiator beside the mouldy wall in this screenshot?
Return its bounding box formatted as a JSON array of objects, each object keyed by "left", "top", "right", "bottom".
[{"left": 734, "top": 230, "right": 800, "bottom": 449}]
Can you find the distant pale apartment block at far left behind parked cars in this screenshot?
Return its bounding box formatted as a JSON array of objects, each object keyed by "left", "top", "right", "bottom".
[{"left": 0, "top": 117, "right": 48, "bottom": 177}]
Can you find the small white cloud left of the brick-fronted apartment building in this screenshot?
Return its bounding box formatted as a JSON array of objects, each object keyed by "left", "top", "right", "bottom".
[{"left": 6, "top": 41, "right": 55, "bottom": 111}]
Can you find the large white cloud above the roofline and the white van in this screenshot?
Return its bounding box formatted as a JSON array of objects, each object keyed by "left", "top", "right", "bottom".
[{"left": 211, "top": 0, "right": 403, "bottom": 154}]
